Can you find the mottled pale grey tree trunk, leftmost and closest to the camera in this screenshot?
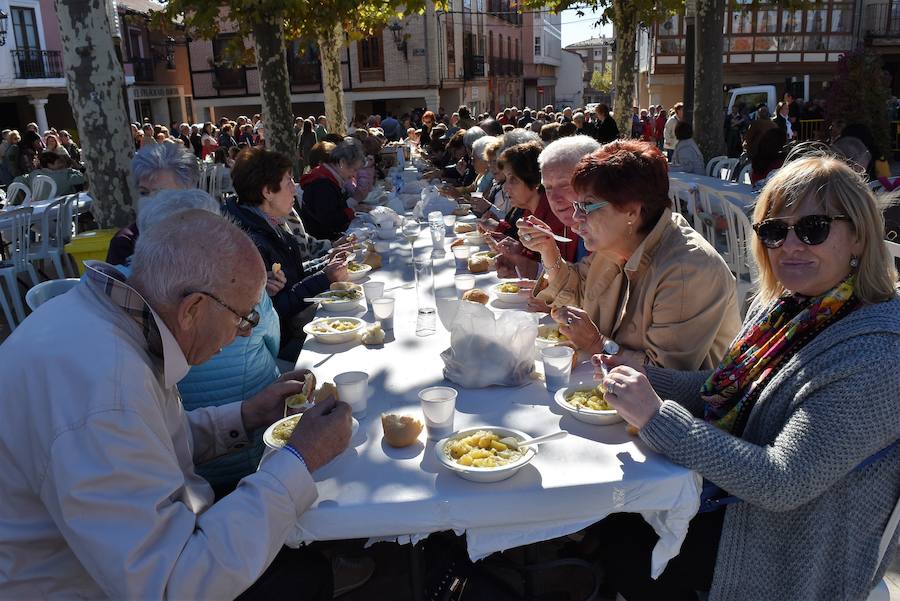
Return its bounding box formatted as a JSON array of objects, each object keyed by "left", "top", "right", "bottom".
[{"left": 56, "top": 0, "right": 138, "bottom": 228}]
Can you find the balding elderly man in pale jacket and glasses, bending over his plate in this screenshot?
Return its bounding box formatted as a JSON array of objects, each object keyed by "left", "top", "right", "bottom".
[{"left": 0, "top": 210, "right": 350, "bottom": 599}]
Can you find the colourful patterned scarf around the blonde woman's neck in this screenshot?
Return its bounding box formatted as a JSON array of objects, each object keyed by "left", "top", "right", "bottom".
[{"left": 700, "top": 275, "right": 858, "bottom": 436}]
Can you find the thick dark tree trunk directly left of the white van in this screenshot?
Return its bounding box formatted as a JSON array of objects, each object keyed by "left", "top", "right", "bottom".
[{"left": 694, "top": 0, "right": 725, "bottom": 161}]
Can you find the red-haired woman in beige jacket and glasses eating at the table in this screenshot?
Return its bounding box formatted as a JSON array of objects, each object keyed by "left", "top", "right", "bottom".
[{"left": 519, "top": 140, "right": 740, "bottom": 369}]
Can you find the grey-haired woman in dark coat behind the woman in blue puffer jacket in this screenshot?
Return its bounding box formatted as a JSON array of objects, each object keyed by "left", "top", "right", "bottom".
[{"left": 106, "top": 144, "right": 200, "bottom": 265}]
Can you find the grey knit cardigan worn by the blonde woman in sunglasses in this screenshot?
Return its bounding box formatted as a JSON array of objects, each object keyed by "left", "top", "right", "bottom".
[{"left": 640, "top": 298, "right": 900, "bottom": 601}]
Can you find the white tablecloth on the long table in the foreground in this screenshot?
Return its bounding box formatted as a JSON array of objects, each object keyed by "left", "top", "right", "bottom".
[{"left": 289, "top": 218, "right": 700, "bottom": 576}]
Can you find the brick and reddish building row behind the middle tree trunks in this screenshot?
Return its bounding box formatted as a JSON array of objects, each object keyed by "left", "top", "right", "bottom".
[{"left": 188, "top": 0, "right": 502, "bottom": 121}]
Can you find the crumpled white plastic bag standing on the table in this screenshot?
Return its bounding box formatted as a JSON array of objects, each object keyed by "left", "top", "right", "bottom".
[{"left": 441, "top": 301, "right": 537, "bottom": 388}]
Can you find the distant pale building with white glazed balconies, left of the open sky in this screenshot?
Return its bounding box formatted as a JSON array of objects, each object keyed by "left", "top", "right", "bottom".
[{"left": 522, "top": 11, "right": 562, "bottom": 108}]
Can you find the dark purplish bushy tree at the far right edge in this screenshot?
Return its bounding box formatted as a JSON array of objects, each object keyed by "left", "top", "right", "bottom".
[{"left": 825, "top": 48, "right": 891, "bottom": 158}]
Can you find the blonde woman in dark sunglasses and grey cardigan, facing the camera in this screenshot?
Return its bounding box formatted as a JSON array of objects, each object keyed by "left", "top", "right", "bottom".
[{"left": 595, "top": 156, "right": 900, "bottom": 601}]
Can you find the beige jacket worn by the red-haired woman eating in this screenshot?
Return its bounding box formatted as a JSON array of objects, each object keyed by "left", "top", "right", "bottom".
[{"left": 538, "top": 209, "right": 741, "bottom": 370}]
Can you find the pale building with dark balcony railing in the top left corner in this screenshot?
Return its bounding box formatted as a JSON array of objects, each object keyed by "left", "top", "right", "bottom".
[{"left": 0, "top": 0, "right": 75, "bottom": 133}]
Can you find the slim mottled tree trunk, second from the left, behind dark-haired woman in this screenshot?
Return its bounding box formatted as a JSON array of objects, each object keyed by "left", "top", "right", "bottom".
[{"left": 253, "top": 13, "right": 298, "bottom": 165}]
